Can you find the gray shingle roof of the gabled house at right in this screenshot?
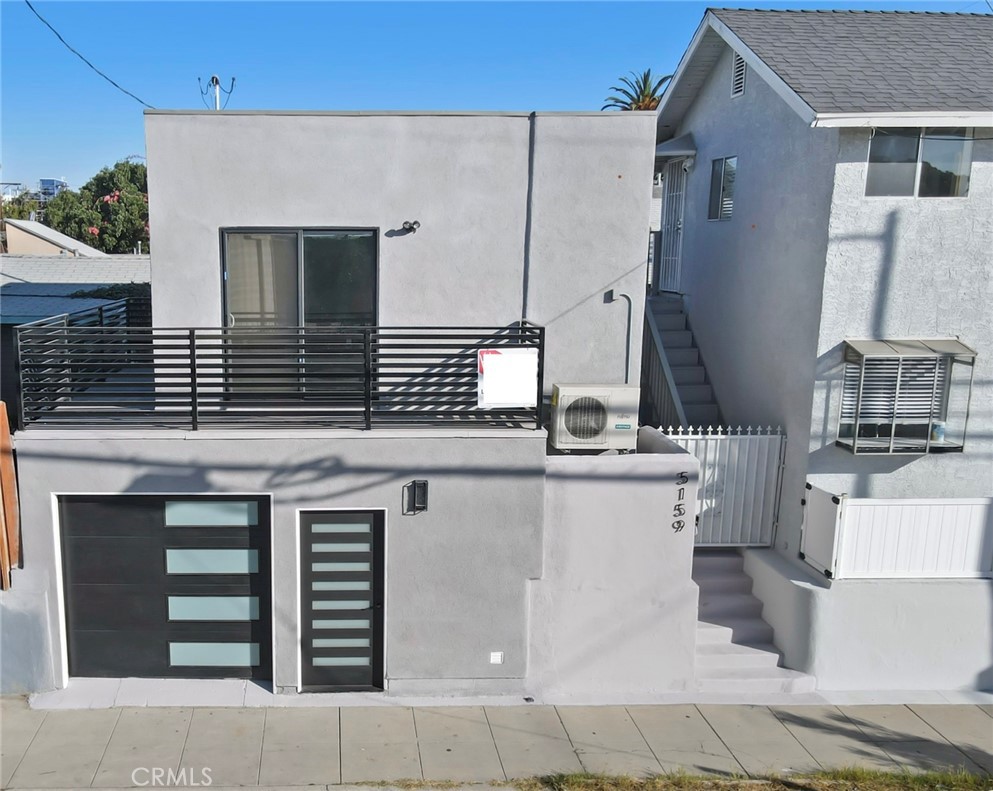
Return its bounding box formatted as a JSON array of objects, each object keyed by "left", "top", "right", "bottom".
[{"left": 710, "top": 9, "right": 993, "bottom": 113}]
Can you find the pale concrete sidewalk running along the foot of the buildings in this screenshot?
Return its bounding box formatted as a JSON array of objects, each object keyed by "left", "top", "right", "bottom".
[{"left": 0, "top": 698, "right": 993, "bottom": 789}]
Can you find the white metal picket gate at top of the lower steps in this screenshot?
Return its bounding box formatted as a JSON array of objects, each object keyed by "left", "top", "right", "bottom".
[{"left": 659, "top": 426, "right": 786, "bottom": 547}]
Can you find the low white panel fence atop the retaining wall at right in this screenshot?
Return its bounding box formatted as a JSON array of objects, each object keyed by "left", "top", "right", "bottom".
[{"left": 800, "top": 484, "right": 993, "bottom": 579}]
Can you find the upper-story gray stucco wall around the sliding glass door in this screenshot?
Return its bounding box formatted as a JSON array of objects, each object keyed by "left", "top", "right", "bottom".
[{"left": 145, "top": 112, "right": 654, "bottom": 390}]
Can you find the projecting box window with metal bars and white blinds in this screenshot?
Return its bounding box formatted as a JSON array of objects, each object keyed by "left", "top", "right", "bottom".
[{"left": 837, "top": 341, "right": 975, "bottom": 454}]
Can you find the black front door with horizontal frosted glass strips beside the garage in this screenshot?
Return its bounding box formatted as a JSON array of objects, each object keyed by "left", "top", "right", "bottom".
[{"left": 300, "top": 511, "right": 386, "bottom": 692}]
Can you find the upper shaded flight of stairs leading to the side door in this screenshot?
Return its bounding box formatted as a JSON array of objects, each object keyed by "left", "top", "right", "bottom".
[{"left": 649, "top": 294, "right": 721, "bottom": 427}]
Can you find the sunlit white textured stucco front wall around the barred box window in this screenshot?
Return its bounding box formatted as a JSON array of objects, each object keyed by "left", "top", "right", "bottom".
[{"left": 809, "top": 129, "right": 993, "bottom": 497}]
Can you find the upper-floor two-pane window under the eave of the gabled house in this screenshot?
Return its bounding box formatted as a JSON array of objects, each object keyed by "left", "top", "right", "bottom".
[{"left": 865, "top": 127, "right": 972, "bottom": 198}]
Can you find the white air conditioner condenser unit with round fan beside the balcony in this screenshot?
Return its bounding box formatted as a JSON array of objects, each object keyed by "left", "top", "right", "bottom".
[{"left": 551, "top": 384, "right": 641, "bottom": 450}]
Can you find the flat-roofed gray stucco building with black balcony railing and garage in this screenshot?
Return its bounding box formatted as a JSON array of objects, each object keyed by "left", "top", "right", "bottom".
[{"left": 0, "top": 111, "right": 712, "bottom": 699}]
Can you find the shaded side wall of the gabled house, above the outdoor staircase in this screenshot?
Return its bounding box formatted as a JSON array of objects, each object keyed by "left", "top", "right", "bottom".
[{"left": 675, "top": 49, "right": 838, "bottom": 553}]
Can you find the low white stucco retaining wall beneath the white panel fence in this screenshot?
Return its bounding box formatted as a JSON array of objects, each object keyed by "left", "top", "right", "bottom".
[{"left": 745, "top": 550, "right": 993, "bottom": 691}]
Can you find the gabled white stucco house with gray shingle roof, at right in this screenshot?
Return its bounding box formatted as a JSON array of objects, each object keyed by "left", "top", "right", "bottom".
[{"left": 646, "top": 9, "right": 993, "bottom": 689}]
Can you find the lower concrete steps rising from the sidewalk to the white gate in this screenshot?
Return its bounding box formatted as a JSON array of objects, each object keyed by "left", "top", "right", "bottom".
[{"left": 693, "top": 549, "right": 817, "bottom": 694}]
